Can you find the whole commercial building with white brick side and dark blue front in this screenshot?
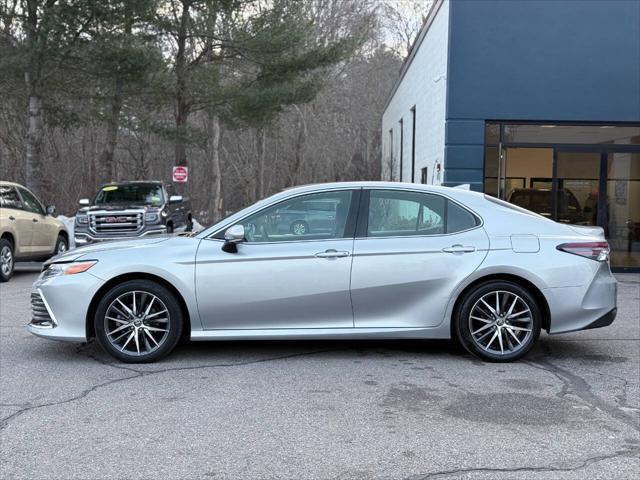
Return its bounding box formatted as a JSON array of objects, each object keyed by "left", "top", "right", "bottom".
[{"left": 382, "top": 0, "right": 640, "bottom": 270}]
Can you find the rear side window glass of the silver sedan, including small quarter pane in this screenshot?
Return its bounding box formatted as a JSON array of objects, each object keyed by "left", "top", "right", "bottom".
[{"left": 367, "top": 190, "right": 479, "bottom": 237}]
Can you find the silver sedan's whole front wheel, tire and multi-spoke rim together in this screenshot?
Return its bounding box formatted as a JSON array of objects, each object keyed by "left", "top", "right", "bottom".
[{"left": 94, "top": 280, "right": 182, "bottom": 363}]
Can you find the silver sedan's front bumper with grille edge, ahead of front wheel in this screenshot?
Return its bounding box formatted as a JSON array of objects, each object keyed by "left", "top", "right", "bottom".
[{"left": 27, "top": 272, "right": 104, "bottom": 342}]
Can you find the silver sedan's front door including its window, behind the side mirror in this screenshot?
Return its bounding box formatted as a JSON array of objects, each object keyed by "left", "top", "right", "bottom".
[{"left": 196, "top": 189, "right": 359, "bottom": 329}]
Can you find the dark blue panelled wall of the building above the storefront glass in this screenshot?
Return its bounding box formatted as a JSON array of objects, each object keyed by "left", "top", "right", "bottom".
[{"left": 444, "top": 0, "right": 640, "bottom": 190}]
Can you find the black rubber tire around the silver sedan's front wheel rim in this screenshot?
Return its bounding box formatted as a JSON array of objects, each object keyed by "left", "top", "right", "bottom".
[{"left": 93, "top": 280, "right": 183, "bottom": 363}]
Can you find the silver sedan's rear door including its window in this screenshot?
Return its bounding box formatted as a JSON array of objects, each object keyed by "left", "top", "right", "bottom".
[{"left": 351, "top": 189, "right": 489, "bottom": 328}]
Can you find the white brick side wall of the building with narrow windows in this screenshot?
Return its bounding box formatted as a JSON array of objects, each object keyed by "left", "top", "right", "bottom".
[{"left": 382, "top": 0, "right": 449, "bottom": 185}]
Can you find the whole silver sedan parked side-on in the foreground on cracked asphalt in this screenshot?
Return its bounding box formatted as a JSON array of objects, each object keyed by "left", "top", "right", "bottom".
[{"left": 28, "top": 182, "right": 616, "bottom": 362}]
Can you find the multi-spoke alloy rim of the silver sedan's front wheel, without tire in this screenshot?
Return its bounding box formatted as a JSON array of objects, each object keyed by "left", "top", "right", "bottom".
[{"left": 104, "top": 290, "right": 171, "bottom": 356}]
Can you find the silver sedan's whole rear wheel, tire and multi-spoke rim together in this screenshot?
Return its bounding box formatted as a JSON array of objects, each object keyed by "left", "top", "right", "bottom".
[{"left": 455, "top": 281, "right": 541, "bottom": 362}]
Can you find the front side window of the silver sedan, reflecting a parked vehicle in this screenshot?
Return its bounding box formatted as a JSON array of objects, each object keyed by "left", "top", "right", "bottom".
[{"left": 240, "top": 190, "right": 352, "bottom": 243}]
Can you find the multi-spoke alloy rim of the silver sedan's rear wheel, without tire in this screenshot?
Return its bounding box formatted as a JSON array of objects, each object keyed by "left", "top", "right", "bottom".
[{"left": 469, "top": 290, "right": 533, "bottom": 355}]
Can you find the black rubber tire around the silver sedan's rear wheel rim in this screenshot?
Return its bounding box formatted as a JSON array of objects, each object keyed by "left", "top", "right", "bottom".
[{"left": 454, "top": 280, "right": 542, "bottom": 362}]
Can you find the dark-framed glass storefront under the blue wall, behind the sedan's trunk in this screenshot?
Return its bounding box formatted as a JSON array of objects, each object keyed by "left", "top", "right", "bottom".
[{"left": 484, "top": 122, "right": 640, "bottom": 269}]
